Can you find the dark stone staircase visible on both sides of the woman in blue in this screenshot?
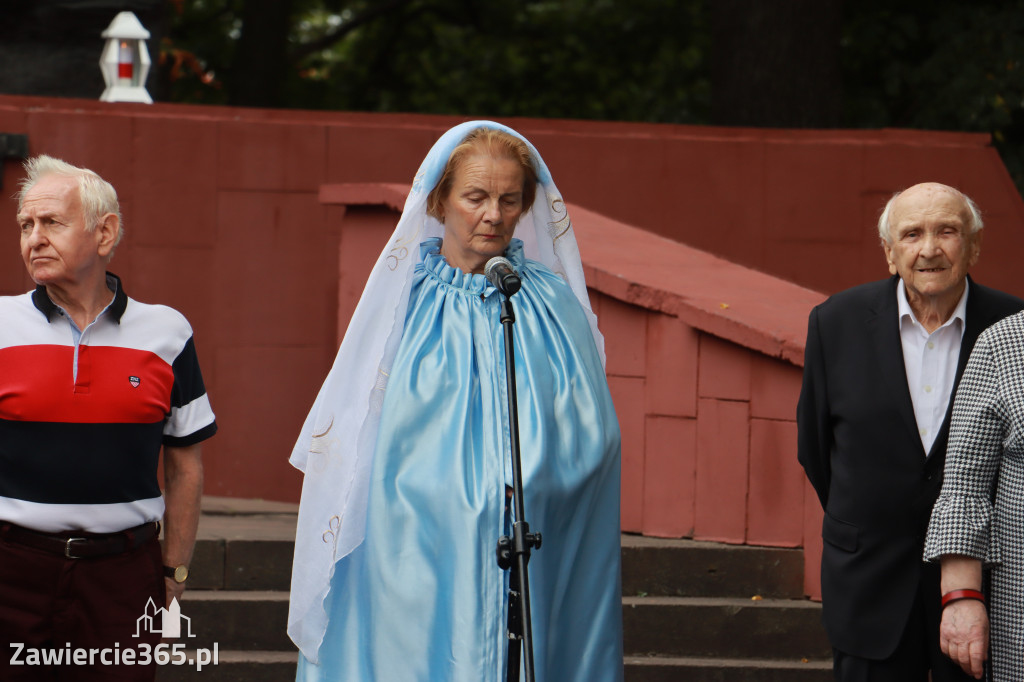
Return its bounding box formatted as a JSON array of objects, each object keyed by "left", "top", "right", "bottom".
[{"left": 157, "top": 498, "right": 831, "bottom": 682}]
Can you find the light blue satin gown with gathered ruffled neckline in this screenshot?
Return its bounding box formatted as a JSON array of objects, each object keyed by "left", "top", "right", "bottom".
[{"left": 297, "top": 240, "right": 623, "bottom": 682}]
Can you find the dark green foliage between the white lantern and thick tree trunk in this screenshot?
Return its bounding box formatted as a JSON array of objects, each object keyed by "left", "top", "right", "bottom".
[{"left": 163, "top": 0, "right": 710, "bottom": 123}]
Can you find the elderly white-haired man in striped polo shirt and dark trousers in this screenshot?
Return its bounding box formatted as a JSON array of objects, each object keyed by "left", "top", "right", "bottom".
[{"left": 0, "top": 156, "right": 217, "bottom": 682}]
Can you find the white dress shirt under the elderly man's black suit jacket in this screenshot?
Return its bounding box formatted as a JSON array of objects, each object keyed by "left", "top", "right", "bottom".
[{"left": 896, "top": 280, "right": 969, "bottom": 454}]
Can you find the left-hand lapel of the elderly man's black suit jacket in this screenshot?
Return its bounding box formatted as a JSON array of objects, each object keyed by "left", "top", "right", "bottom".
[{"left": 867, "top": 276, "right": 925, "bottom": 459}]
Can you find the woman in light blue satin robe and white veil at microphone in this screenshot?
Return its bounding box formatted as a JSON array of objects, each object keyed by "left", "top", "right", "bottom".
[{"left": 289, "top": 122, "right": 623, "bottom": 682}]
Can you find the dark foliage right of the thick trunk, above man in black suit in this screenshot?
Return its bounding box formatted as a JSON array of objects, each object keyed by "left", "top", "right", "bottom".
[{"left": 842, "top": 0, "right": 1024, "bottom": 189}]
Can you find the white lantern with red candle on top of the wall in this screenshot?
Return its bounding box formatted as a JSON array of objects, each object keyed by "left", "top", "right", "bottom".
[{"left": 99, "top": 12, "right": 153, "bottom": 104}]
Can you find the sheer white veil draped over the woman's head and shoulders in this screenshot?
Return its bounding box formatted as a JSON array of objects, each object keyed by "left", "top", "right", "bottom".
[{"left": 288, "top": 121, "right": 604, "bottom": 663}]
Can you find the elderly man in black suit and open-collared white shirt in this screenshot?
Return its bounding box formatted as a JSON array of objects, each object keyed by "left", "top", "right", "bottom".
[{"left": 797, "top": 182, "right": 1024, "bottom": 682}]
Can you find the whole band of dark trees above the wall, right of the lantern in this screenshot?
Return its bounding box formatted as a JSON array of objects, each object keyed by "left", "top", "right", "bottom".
[{"left": 156, "top": 0, "right": 1024, "bottom": 187}]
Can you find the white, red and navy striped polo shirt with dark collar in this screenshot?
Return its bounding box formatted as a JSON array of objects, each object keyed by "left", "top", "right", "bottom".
[{"left": 0, "top": 274, "right": 217, "bottom": 532}]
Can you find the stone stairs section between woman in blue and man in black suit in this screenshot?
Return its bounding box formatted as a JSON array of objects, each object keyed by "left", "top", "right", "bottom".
[{"left": 623, "top": 536, "right": 833, "bottom": 682}]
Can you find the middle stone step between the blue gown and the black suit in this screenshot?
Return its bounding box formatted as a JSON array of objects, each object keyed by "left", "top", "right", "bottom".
[{"left": 623, "top": 597, "right": 831, "bottom": 660}]
